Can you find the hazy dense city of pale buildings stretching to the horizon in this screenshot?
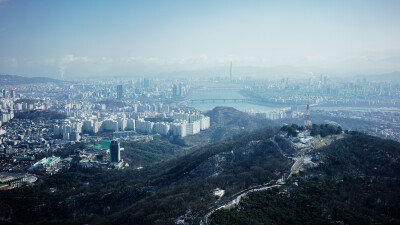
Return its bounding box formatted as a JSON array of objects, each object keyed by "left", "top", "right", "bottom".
[{"left": 0, "top": 75, "right": 400, "bottom": 185}]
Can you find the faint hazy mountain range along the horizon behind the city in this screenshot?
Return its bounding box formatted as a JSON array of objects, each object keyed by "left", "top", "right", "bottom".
[{"left": 0, "top": 70, "right": 400, "bottom": 85}]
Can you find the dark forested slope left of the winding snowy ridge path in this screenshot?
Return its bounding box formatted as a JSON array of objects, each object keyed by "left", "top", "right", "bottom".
[{"left": 0, "top": 128, "right": 291, "bottom": 224}]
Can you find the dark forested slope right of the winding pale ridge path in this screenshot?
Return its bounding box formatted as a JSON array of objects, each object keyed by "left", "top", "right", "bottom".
[{"left": 211, "top": 132, "right": 400, "bottom": 225}]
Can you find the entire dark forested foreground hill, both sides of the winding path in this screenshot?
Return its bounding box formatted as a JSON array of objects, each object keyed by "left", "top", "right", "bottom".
[{"left": 0, "top": 126, "right": 400, "bottom": 224}]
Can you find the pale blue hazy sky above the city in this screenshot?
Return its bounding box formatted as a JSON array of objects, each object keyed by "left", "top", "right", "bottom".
[{"left": 0, "top": 0, "right": 400, "bottom": 78}]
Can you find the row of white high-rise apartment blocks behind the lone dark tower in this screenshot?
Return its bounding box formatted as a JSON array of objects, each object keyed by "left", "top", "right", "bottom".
[{"left": 53, "top": 112, "right": 210, "bottom": 141}]
